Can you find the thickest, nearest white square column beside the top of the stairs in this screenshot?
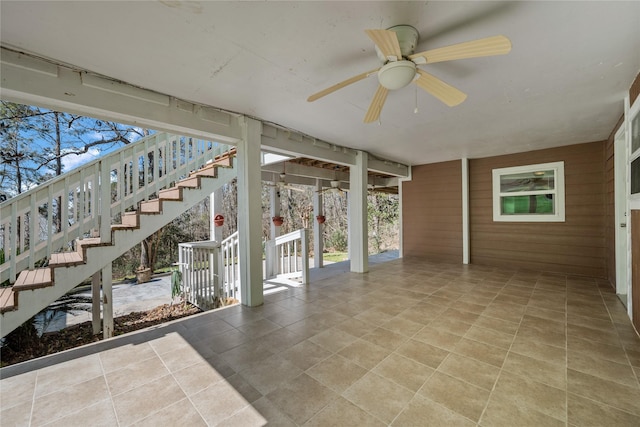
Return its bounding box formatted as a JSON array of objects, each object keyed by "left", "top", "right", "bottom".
[{"left": 236, "top": 118, "right": 264, "bottom": 307}]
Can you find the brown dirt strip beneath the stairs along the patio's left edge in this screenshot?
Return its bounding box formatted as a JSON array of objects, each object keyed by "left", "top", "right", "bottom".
[{"left": 0, "top": 304, "right": 201, "bottom": 366}]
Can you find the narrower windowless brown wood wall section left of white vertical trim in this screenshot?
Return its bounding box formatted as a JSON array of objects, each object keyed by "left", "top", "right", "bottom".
[{"left": 402, "top": 160, "right": 462, "bottom": 263}]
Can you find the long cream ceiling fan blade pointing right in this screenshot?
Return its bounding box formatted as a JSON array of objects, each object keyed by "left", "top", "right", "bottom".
[{"left": 409, "top": 36, "right": 511, "bottom": 64}]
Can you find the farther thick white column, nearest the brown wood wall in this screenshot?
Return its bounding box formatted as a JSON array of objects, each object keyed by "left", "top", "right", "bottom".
[{"left": 349, "top": 151, "right": 369, "bottom": 273}]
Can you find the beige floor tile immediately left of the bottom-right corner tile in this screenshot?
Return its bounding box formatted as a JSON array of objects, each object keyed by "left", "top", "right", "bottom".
[{"left": 491, "top": 370, "right": 567, "bottom": 422}]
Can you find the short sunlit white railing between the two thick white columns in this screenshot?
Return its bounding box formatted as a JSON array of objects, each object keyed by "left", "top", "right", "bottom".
[{"left": 265, "top": 228, "right": 309, "bottom": 285}]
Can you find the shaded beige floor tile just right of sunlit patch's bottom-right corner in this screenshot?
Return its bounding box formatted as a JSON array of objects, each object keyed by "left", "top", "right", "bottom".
[{"left": 266, "top": 374, "right": 338, "bottom": 424}]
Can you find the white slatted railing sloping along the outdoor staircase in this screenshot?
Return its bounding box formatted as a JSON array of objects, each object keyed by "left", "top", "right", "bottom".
[{"left": 0, "top": 133, "right": 231, "bottom": 283}]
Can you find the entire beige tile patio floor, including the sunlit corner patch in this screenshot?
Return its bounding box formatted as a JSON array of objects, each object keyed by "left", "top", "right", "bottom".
[{"left": 0, "top": 260, "right": 640, "bottom": 427}]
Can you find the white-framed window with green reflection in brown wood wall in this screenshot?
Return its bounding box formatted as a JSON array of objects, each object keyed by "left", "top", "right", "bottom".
[{"left": 493, "top": 162, "right": 564, "bottom": 222}]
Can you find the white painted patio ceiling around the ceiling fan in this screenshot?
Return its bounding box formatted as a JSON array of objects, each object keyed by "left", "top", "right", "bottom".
[{"left": 0, "top": 0, "right": 640, "bottom": 164}]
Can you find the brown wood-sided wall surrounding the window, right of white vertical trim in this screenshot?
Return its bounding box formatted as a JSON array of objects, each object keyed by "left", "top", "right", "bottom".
[{"left": 469, "top": 142, "right": 607, "bottom": 278}]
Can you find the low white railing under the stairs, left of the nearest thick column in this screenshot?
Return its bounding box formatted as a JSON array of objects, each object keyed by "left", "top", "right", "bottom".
[{"left": 178, "top": 231, "right": 240, "bottom": 310}]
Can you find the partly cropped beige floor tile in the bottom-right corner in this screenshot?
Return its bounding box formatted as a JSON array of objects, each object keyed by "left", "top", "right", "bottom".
[{"left": 567, "top": 393, "right": 640, "bottom": 427}]
